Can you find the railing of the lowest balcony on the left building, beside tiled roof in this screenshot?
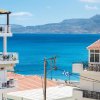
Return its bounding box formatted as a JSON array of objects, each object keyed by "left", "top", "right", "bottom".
[{"left": 0, "top": 79, "right": 15, "bottom": 89}]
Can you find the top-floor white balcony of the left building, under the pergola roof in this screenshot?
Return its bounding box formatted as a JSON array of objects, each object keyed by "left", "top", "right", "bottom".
[{"left": 0, "top": 25, "right": 12, "bottom": 36}]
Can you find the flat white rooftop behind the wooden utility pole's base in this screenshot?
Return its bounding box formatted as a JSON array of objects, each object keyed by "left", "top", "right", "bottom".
[{"left": 7, "top": 86, "right": 73, "bottom": 100}]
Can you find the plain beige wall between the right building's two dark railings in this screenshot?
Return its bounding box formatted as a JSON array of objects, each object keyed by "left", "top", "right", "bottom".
[{"left": 80, "top": 71, "right": 100, "bottom": 92}]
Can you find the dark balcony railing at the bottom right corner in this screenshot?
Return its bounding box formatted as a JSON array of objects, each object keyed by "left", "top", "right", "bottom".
[{"left": 83, "top": 90, "right": 100, "bottom": 100}]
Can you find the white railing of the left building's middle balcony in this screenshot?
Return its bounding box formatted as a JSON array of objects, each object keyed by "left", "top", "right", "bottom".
[{"left": 0, "top": 53, "right": 18, "bottom": 61}]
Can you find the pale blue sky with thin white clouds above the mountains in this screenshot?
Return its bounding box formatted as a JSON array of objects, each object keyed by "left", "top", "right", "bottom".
[{"left": 0, "top": 0, "right": 100, "bottom": 26}]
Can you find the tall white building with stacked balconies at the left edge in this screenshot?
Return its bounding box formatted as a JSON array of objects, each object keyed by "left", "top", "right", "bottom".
[{"left": 0, "top": 10, "right": 18, "bottom": 100}]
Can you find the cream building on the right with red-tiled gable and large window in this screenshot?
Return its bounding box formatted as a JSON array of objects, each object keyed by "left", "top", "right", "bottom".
[{"left": 73, "top": 40, "right": 100, "bottom": 100}]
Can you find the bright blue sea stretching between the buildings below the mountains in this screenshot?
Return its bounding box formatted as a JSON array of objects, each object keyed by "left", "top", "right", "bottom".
[{"left": 0, "top": 33, "right": 100, "bottom": 80}]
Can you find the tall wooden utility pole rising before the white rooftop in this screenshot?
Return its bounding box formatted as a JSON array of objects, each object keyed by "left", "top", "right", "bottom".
[{"left": 44, "top": 58, "right": 47, "bottom": 100}]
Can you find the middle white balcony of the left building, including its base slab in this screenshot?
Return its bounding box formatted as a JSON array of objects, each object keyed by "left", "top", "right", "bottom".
[{"left": 0, "top": 53, "right": 19, "bottom": 64}]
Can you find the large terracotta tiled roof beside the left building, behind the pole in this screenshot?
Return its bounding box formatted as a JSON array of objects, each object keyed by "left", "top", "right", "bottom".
[{"left": 8, "top": 72, "right": 58, "bottom": 91}]
